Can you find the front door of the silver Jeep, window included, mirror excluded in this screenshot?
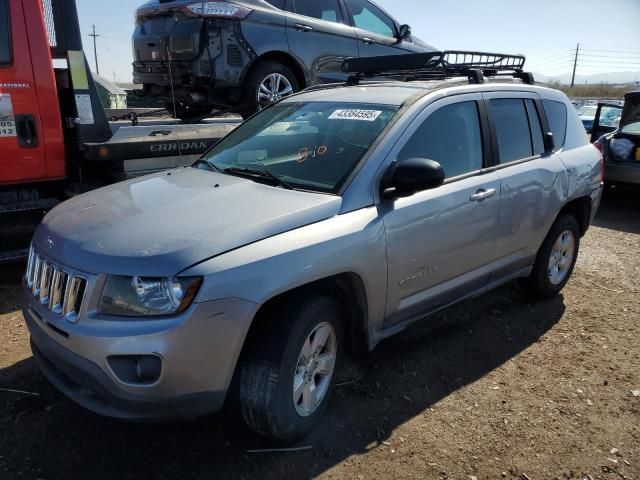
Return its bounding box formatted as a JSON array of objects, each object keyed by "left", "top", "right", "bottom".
[{"left": 381, "top": 94, "right": 500, "bottom": 326}]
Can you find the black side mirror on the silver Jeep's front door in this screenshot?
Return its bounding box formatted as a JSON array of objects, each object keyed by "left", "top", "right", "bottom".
[{"left": 382, "top": 158, "right": 445, "bottom": 198}]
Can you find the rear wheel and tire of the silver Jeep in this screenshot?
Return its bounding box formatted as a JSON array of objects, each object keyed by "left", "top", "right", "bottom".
[{"left": 521, "top": 214, "right": 581, "bottom": 300}]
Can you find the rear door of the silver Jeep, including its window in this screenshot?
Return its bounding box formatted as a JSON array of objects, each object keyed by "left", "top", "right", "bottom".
[{"left": 484, "top": 92, "right": 566, "bottom": 280}]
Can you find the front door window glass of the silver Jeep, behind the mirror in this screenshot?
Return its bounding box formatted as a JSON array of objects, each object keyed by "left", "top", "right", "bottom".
[{"left": 398, "top": 101, "right": 483, "bottom": 178}]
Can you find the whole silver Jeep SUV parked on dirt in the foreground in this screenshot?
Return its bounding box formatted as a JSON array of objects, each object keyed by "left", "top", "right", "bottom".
[{"left": 24, "top": 52, "right": 602, "bottom": 441}]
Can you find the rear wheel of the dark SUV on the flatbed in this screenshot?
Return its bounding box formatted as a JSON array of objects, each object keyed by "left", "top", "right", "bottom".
[{"left": 239, "top": 61, "right": 300, "bottom": 119}]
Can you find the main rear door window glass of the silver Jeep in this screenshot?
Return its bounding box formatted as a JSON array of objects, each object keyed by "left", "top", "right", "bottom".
[{"left": 490, "top": 98, "right": 533, "bottom": 163}]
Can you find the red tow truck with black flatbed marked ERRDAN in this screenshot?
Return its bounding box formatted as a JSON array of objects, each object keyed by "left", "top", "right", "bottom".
[{"left": 0, "top": 0, "right": 238, "bottom": 262}]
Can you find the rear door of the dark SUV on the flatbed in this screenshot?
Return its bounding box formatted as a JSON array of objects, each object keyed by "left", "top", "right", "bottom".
[{"left": 286, "top": 0, "right": 358, "bottom": 84}]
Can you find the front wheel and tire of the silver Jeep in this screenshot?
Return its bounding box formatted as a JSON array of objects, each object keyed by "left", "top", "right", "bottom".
[{"left": 240, "top": 296, "right": 343, "bottom": 443}]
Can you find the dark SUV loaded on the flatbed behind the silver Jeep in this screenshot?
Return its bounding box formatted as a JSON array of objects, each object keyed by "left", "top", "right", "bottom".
[{"left": 133, "top": 0, "right": 435, "bottom": 119}]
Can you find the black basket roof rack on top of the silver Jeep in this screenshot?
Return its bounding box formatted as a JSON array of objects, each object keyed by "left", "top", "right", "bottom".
[{"left": 342, "top": 50, "right": 534, "bottom": 85}]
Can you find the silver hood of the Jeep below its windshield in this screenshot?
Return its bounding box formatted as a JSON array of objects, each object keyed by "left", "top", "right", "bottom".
[{"left": 34, "top": 167, "right": 342, "bottom": 276}]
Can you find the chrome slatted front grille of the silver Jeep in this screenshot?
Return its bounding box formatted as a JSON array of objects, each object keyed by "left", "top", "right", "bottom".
[{"left": 26, "top": 245, "right": 87, "bottom": 323}]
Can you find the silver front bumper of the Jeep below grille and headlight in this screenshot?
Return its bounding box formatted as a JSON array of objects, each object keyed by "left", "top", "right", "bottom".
[{"left": 23, "top": 288, "right": 256, "bottom": 421}]
